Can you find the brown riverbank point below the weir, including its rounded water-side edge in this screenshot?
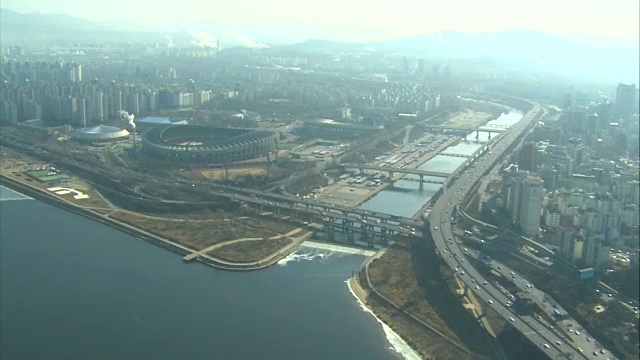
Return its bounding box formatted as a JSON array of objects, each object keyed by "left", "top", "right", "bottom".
[{"left": 350, "top": 246, "right": 490, "bottom": 360}]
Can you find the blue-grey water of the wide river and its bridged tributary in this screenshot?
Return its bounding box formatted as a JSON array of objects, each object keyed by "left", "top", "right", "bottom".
[{"left": 0, "top": 111, "right": 522, "bottom": 360}]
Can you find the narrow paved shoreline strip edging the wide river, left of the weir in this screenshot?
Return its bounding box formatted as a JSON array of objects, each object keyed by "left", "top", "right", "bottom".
[{"left": 0, "top": 174, "right": 312, "bottom": 271}]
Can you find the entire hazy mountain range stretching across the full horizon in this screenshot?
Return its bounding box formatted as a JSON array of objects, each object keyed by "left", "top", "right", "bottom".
[{"left": 0, "top": 9, "right": 640, "bottom": 83}]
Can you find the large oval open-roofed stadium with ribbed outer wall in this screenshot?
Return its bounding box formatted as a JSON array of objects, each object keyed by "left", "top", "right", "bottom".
[{"left": 141, "top": 125, "right": 279, "bottom": 164}]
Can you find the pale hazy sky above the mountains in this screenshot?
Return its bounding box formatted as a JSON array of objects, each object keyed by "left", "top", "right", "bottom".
[{"left": 0, "top": 0, "right": 640, "bottom": 40}]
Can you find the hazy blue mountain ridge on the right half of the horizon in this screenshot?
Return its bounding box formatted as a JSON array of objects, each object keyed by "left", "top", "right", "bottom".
[{"left": 280, "top": 30, "right": 640, "bottom": 83}]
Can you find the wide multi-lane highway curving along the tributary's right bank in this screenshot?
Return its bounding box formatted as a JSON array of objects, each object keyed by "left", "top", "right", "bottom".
[{"left": 429, "top": 104, "right": 586, "bottom": 359}]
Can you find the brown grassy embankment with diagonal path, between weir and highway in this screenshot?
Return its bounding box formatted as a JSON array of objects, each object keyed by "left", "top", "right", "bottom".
[{"left": 367, "top": 244, "right": 492, "bottom": 360}]
